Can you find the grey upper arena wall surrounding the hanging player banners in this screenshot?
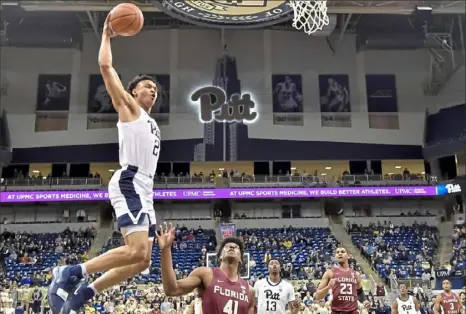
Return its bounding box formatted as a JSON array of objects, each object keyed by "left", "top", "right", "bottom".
[{"left": 1, "top": 30, "right": 465, "bottom": 148}]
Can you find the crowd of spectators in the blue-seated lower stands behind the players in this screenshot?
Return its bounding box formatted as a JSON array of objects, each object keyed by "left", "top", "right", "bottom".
[{"left": 0, "top": 222, "right": 466, "bottom": 314}]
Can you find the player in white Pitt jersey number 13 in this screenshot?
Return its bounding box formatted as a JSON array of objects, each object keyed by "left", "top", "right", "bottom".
[{"left": 254, "top": 258, "right": 300, "bottom": 314}]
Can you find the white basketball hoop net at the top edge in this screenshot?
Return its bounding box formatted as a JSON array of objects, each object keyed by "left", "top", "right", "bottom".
[{"left": 290, "top": 0, "right": 330, "bottom": 35}]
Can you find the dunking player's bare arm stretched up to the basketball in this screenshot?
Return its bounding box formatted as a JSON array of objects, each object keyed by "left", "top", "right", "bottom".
[{"left": 99, "top": 14, "right": 132, "bottom": 112}]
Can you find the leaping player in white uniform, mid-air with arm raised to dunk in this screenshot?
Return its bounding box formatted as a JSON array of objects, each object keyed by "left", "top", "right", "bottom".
[{"left": 48, "top": 12, "right": 160, "bottom": 314}]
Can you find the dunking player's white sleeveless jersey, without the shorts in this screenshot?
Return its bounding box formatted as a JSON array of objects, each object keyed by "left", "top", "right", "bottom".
[{"left": 117, "top": 108, "right": 161, "bottom": 177}]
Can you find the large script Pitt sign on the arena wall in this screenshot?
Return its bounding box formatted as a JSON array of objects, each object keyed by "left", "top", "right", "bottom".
[{"left": 191, "top": 86, "right": 259, "bottom": 123}]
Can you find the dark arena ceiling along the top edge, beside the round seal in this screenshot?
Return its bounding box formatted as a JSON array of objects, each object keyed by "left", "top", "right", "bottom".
[{"left": 0, "top": 0, "right": 466, "bottom": 45}]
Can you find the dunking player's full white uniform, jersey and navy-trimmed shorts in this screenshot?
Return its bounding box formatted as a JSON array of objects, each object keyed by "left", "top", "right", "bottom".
[{"left": 108, "top": 108, "right": 161, "bottom": 238}]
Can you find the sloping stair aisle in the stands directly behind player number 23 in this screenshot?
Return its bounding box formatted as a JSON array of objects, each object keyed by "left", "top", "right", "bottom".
[{"left": 329, "top": 217, "right": 383, "bottom": 286}]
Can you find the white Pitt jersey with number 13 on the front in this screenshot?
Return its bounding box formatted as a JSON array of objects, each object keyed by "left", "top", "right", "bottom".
[{"left": 254, "top": 277, "right": 295, "bottom": 314}]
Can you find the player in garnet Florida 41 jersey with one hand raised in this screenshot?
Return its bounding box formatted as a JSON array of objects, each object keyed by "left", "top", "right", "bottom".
[{"left": 157, "top": 223, "right": 255, "bottom": 314}]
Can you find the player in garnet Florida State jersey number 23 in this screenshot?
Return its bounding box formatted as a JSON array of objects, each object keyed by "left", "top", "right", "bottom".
[{"left": 314, "top": 247, "right": 370, "bottom": 314}]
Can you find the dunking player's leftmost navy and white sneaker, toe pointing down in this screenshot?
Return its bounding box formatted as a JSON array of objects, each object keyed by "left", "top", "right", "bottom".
[{"left": 47, "top": 266, "right": 81, "bottom": 314}]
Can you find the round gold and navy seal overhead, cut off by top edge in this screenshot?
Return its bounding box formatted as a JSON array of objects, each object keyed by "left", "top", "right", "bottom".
[{"left": 152, "top": 0, "right": 293, "bottom": 28}]
